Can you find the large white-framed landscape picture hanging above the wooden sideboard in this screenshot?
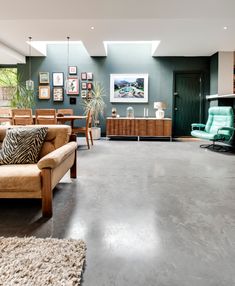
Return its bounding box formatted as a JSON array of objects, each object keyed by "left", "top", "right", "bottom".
[{"left": 110, "top": 74, "right": 148, "bottom": 103}]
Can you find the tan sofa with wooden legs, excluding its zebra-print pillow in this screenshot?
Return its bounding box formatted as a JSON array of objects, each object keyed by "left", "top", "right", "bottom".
[{"left": 0, "top": 125, "right": 77, "bottom": 217}]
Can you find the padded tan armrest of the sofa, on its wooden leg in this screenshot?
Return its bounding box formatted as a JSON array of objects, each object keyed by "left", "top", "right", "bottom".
[{"left": 37, "top": 142, "right": 77, "bottom": 170}]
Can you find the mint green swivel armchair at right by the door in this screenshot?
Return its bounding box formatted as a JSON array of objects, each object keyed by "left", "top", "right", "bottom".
[{"left": 191, "top": 106, "right": 235, "bottom": 149}]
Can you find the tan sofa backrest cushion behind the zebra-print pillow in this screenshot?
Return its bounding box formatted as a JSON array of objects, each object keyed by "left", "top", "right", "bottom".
[{"left": 0, "top": 124, "right": 72, "bottom": 159}]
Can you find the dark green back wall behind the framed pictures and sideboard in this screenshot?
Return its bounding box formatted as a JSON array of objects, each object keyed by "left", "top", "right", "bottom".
[{"left": 19, "top": 43, "right": 210, "bottom": 132}]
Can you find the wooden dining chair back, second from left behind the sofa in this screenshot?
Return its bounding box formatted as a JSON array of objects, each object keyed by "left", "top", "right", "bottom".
[{"left": 12, "top": 108, "right": 33, "bottom": 125}]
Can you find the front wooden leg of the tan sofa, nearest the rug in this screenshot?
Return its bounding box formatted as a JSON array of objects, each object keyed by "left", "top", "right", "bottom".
[{"left": 42, "top": 169, "right": 52, "bottom": 217}]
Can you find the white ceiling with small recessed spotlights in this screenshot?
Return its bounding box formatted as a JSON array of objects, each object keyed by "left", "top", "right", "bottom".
[{"left": 0, "top": 0, "right": 235, "bottom": 64}]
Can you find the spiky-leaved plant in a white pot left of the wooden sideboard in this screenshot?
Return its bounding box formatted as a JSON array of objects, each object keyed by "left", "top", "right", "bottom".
[{"left": 83, "top": 82, "right": 106, "bottom": 140}]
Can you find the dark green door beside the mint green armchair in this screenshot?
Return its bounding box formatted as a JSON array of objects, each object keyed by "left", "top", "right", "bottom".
[{"left": 173, "top": 73, "right": 201, "bottom": 136}]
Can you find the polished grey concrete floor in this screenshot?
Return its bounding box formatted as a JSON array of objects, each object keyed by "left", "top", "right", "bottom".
[{"left": 0, "top": 140, "right": 235, "bottom": 286}]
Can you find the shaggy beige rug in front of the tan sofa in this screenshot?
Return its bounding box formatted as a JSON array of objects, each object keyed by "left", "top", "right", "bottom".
[{"left": 0, "top": 237, "right": 86, "bottom": 286}]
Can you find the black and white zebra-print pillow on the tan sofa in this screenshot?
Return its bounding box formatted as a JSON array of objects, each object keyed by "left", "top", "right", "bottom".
[{"left": 0, "top": 127, "right": 48, "bottom": 165}]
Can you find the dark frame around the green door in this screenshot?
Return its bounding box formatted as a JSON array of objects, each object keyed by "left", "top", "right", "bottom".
[{"left": 172, "top": 70, "right": 205, "bottom": 137}]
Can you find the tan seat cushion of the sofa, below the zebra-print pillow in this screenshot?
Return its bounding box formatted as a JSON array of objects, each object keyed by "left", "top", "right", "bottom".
[{"left": 0, "top": 164, "right": 41, "bottom": 193}]
